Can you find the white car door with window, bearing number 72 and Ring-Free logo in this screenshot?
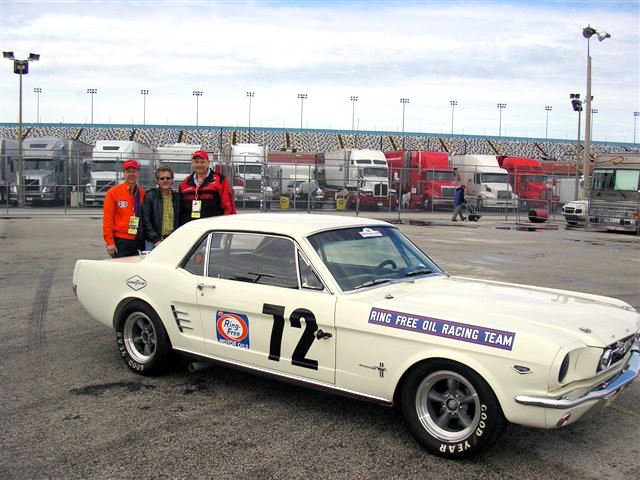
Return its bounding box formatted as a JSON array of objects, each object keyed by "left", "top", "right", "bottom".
[{"left": 196, "top": 232, "right": 336, "bottom": 384}]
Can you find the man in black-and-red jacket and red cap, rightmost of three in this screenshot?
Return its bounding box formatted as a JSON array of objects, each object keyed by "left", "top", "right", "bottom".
[{"left": 178, "top": 150, "right": 236, "bottom": 224}]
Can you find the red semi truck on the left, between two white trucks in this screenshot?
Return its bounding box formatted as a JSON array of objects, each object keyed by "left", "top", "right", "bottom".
[{"left": 385, "top": 150, "right": 456, "bottom": 210}]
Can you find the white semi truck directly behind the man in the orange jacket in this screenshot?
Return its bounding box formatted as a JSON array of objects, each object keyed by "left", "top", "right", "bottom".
[{"left": 85, "top": 140, "right": 155, "bottom": 205}]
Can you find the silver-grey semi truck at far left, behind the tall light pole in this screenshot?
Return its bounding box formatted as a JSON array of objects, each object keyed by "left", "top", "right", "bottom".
[{"left": 9, "top": 137, "right": 91, "bottom": 204}]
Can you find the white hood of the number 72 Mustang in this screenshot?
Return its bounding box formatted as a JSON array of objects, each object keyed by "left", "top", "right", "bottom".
[{"left": 365, "top": 275, "right": 640, "bottom": 347}]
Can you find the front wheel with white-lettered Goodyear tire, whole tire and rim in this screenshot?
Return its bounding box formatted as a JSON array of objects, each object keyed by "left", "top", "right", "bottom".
[{"left": 401, "top": 360, "right": 506, "bottom": 459}]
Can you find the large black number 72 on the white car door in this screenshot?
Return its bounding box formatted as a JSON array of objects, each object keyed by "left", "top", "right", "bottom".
[{"left": 262, "top": 303, "right": 318, "bottom": 370}]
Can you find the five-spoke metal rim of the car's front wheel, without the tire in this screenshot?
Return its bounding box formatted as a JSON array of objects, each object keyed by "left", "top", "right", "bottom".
[{"left": 415, "top": 370, "right": 480, "bottom": 442}]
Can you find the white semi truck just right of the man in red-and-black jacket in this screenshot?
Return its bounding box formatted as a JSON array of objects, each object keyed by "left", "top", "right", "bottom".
[{"left": 220, "top": 143, "right": 273, "bottom": 209}]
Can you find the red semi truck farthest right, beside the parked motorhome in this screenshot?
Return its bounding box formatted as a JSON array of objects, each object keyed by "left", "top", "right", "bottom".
[{"left": 497, "top": 155, "right": 559, "bottom": 210}]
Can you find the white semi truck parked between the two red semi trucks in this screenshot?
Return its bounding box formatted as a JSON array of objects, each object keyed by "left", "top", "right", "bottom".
[{"left": 451, "top": 155, "right": 518, "bottom": 209}]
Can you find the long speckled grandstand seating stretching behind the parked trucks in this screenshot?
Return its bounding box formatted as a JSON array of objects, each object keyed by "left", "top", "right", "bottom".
[{"left": 0, "top": 124, "right": 640, "bottom": 158}]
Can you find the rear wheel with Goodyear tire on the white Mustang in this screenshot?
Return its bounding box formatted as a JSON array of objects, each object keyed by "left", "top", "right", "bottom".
[{"left": 116, "top": 300, "right": 174, "bottom": 376}]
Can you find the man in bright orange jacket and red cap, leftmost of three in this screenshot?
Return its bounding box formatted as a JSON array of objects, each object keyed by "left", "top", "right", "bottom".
[{"left": 102, "top": 160, "right": 144, "bottom": 257}]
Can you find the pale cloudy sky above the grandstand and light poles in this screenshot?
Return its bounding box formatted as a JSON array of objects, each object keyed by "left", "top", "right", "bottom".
[{"left": 0, "top": 0, "right": 640, "bottom": 142}]
